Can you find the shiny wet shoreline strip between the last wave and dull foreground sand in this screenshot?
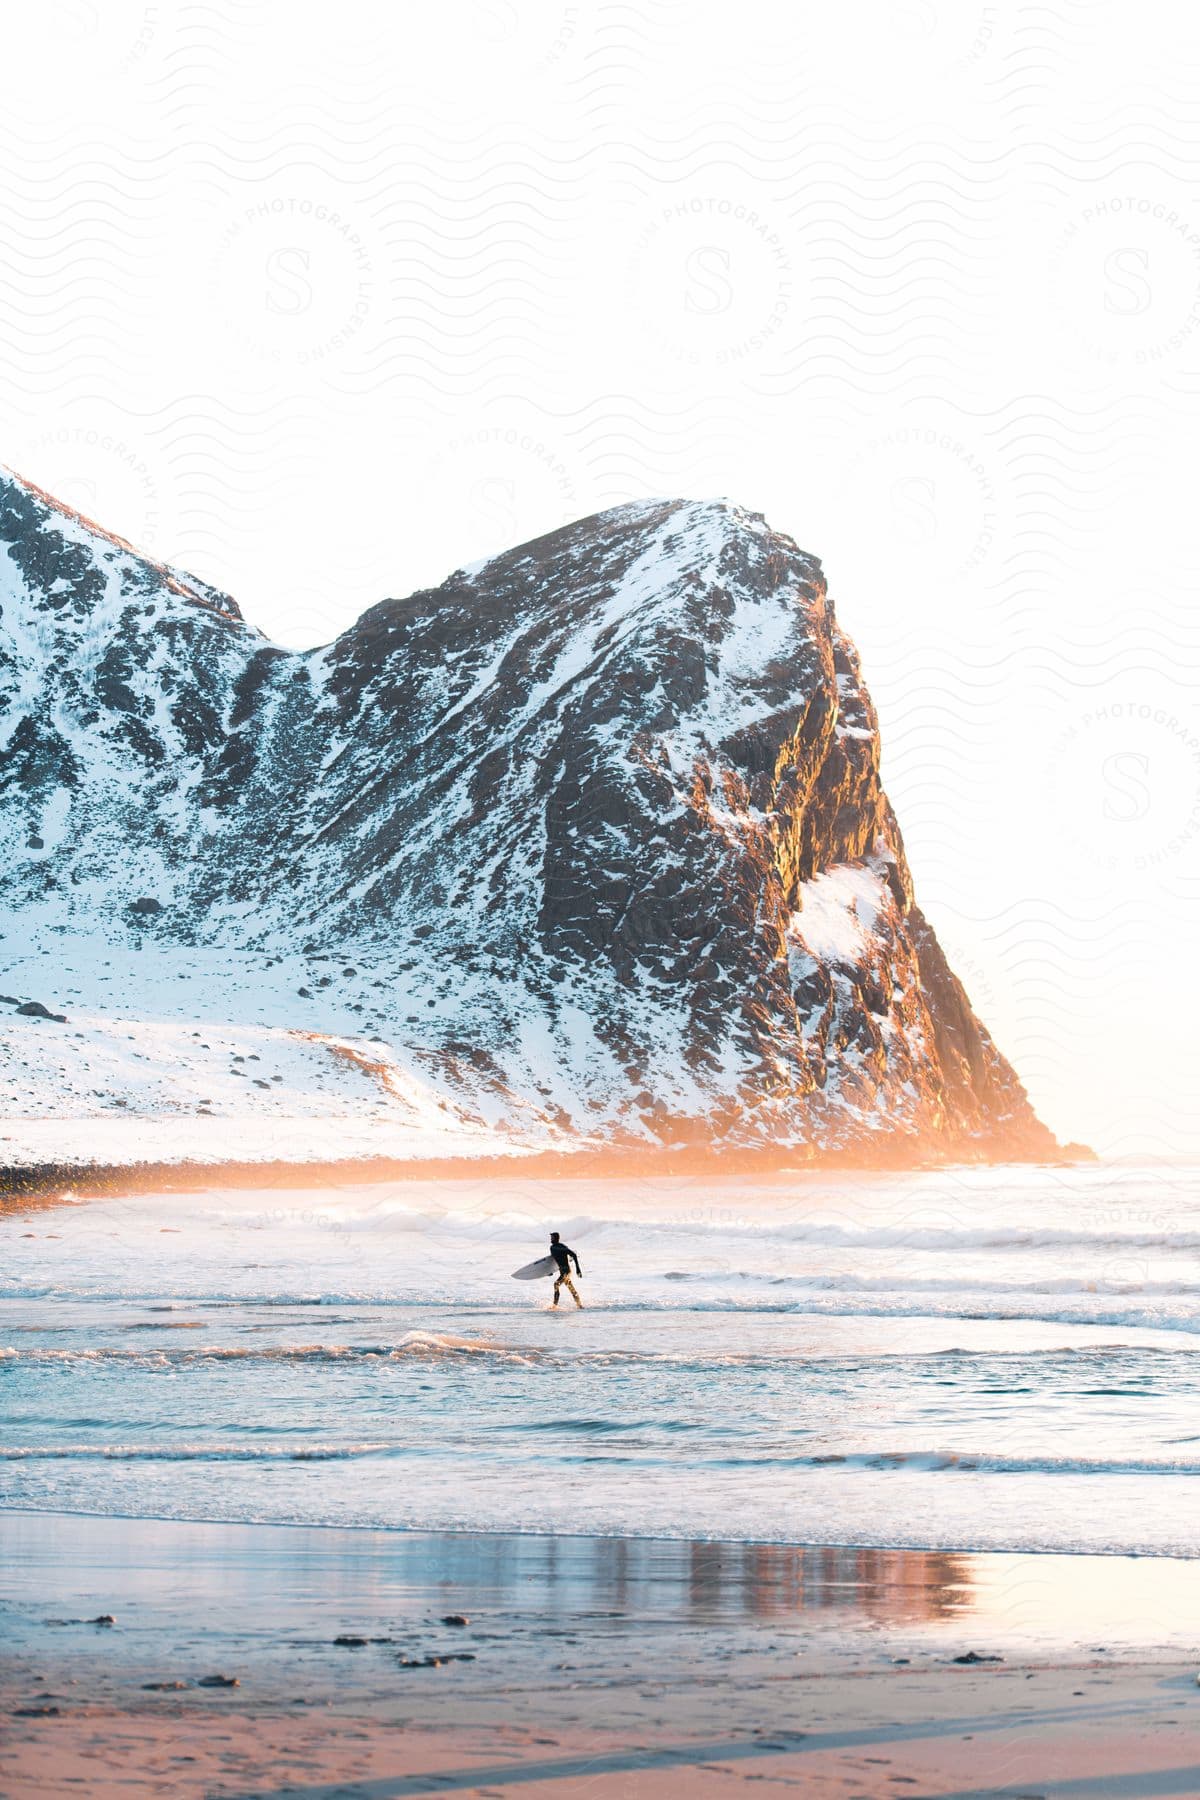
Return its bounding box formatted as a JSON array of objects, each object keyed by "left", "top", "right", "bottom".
[{"left": 9, "top": 1507, "right": 1200, "bottom": 1648}]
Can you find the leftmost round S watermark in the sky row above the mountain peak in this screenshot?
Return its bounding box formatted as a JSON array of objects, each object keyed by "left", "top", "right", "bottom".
[{"left": 214, "top": 194, "right": 380, "bottom": 365}]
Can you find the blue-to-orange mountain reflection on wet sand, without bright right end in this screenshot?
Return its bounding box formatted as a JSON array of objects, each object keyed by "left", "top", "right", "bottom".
[{"left": 0, "top": 1514, "right": 975, "bottom": 1625}]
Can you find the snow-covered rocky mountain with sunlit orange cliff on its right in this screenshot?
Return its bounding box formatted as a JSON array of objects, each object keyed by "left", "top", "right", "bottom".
[{"left": 0, "top": 475, "right": 1054, "bottom": 1165}]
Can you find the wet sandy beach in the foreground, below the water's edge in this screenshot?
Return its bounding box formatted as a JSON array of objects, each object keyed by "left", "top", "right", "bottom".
[{"left": 0, "top": 1514, "right": 1200, "bottom": 1800}]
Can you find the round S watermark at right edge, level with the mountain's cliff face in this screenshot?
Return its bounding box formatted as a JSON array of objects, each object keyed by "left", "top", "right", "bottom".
[{"left": 1054, "top": 697, "right": 1200, "bottom": 873}]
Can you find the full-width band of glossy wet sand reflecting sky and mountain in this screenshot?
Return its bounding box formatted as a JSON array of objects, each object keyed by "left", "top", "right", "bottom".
[{"left": 0, "top": 1512, "right": 1200, "bottom": 1656}]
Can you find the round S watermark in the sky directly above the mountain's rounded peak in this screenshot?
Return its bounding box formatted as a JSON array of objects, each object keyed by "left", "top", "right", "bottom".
[{"left": 630, "top": 194, "right": 797, "bottom": 367}]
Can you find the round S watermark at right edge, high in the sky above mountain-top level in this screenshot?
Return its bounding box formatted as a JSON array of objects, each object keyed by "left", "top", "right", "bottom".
[{"left": 1056, "top": 193, "right": 1200, "bottom": 367}]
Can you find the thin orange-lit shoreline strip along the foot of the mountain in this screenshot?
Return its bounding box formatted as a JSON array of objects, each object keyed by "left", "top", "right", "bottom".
[{"left": 0, "top": 1143, "right": 1099, "bottom": 1211}]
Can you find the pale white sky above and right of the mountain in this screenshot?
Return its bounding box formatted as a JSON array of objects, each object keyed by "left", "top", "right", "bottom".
[{"left": 0, "top": 0, "right": 1200, "bottom": 1157}]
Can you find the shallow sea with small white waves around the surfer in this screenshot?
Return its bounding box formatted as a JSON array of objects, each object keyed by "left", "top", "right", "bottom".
[{"left": 0, "top": 1168, "right": 1200, "bottom": 1555}]
